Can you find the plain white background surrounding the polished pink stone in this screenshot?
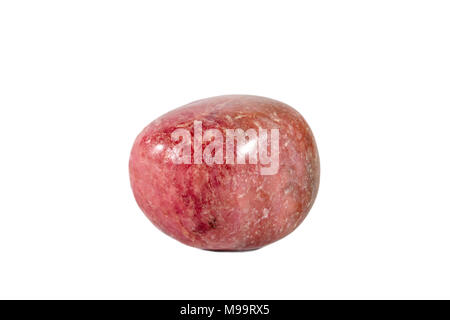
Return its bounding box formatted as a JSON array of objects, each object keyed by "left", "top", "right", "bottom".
[{"left": 0, "top": 0, "right": 450, "bottom": 299}]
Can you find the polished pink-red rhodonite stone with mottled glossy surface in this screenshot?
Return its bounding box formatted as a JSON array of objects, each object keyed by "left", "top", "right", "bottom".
[{"left": 129, "top": 95, "right": 320, "bottom": 251}]
